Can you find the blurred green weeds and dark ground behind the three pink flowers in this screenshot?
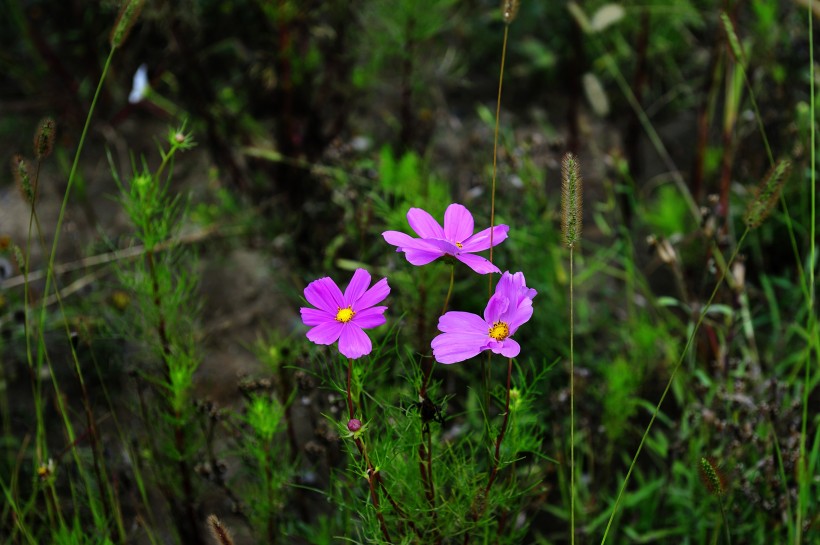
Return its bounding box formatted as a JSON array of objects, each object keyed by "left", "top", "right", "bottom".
[{"left": 0, "top": 0, "right": 820, "bottom": 544}]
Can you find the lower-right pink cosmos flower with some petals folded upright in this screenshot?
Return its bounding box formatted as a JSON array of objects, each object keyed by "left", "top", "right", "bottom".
[{"left": 431, "top": 272, "right": 537, "bottom": 363}]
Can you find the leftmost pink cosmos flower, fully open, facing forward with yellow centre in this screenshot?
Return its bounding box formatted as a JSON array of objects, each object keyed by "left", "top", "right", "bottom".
[{"left": 299, "top": 269, "right": 390, "bottom": 359}]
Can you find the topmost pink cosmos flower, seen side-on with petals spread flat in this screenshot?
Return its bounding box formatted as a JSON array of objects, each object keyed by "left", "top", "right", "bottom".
[{"left": 382, "top": 203, "right": 510, "bottom": 274}]
